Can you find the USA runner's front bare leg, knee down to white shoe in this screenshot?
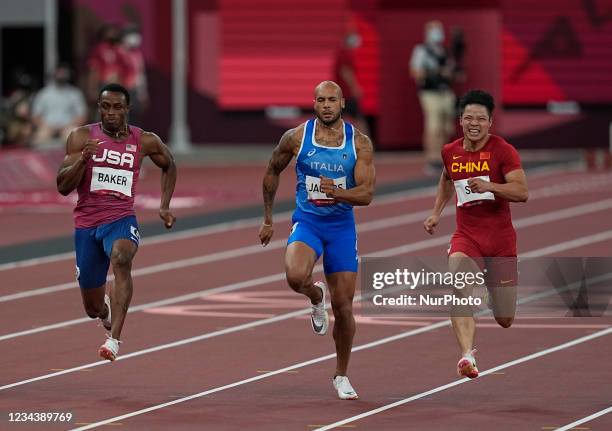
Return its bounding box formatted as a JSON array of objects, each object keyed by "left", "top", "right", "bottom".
[{"left": 110, "top": 239, "right": 138, "bottom": 340}]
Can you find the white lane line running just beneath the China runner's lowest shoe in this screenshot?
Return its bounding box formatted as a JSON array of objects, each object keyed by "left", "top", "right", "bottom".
[{"left": 314, "top": 328, "right": 612, "bottom": 431}]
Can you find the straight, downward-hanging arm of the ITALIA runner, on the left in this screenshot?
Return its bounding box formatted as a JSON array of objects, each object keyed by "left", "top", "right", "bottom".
[{"left": 259, "top": 126, "right": 303, "bottom": 246}]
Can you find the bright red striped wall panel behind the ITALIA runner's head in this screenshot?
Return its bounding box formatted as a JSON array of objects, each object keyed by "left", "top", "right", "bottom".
[{"left": 218, "top": 0, "right": 347, "bottom": 110}]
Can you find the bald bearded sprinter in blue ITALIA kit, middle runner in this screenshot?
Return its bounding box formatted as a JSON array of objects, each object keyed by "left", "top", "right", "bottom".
[{"left": 259, "top": 81, "right": 375, "bottom": 399}]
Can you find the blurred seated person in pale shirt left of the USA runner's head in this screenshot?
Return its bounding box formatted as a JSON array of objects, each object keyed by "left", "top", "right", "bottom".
[{"left": 32, "top": 65, "right": 87, "bottom": 147}]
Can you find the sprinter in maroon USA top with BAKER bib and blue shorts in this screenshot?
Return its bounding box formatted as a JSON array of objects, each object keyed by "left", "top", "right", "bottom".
[{"left": 57, "top": 84, "right": 176, "bottom": 361}]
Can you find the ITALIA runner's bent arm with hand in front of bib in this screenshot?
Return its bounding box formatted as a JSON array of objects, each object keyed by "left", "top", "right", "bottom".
[{"left": 321, "top": 133, "right": 376, "bottom": 206}]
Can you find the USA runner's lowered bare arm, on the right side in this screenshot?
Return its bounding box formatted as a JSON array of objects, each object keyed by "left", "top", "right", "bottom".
[{"left": 140, "top": 132, "right": 176, "bottom": 229}]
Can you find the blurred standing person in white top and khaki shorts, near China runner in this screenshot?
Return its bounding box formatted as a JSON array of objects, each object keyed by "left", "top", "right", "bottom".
[{"left": 410, "top": 21, "right": 455, "bottom": 174}]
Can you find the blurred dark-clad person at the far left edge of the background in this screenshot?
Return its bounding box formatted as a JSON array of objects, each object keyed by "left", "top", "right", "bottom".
[{"left": 2, "top": 70, "right": 34, "bottom": 147}]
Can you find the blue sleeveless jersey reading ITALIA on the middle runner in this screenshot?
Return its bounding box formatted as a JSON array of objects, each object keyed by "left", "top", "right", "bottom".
[{"left": 295, "top": 120, "right": 357, "bottom": 216}]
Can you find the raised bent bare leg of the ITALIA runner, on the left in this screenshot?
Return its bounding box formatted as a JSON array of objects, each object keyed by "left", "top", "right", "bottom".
[{"left": 285, "top": 241, "right": 323, "bottom": 304}]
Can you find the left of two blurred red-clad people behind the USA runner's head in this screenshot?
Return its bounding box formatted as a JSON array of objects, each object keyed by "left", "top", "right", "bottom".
[{"left": 87, "top": 24, "right": 129, "bottom": 105}]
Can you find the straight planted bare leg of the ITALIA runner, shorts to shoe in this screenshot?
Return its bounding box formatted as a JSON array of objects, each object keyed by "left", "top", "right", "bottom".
[{"left": 325, "top": 272, "right": 357, "bottom": 376}]
